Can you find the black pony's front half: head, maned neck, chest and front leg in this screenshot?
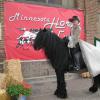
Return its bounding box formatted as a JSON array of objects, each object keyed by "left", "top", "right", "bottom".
[{"left": 33, "top": 29, "right": 100, "bottom": 98}]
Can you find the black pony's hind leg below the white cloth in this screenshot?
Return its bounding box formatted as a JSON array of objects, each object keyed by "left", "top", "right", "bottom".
[{"left": 89, "top": 75, "right": 100, "bottom": 93}]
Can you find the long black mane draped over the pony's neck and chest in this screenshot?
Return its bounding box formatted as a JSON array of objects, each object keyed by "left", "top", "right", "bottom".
[{"left": 38, "top": 30, "right": 69, "bottom": 68}]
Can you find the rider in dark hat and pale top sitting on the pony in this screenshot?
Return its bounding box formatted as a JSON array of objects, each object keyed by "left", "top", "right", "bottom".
[{"left": 68, "top": 16, "right": 81, "bottom": 70}]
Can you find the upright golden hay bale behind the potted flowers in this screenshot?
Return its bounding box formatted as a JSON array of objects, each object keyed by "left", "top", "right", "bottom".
[{"left": 4, "top": 59, "right": 23, "bottom": 82}]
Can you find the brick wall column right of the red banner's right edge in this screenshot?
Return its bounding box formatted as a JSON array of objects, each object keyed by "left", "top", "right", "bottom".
[{"left": 85, "top": 0, "right": 100, "bottom": 44}]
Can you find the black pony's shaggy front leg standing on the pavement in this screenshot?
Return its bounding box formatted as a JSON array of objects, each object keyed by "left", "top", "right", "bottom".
[{"left": 54, "top": 70, "right": 67, "bottom": 98}]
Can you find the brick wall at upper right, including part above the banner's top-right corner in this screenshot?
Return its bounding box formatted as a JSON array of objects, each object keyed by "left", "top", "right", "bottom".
[{"left": 76, "top": 0, "right": 100, "bottom": 44}]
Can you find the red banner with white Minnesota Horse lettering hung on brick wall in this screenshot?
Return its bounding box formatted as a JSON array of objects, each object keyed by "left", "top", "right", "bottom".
[{"left": 4, "top": 2, "right": 85, "bottom": 60}]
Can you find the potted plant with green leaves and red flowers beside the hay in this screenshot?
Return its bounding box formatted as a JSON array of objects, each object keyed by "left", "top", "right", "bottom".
[{"left": 6, "top": 82, "right": 32, "bottom": 100}]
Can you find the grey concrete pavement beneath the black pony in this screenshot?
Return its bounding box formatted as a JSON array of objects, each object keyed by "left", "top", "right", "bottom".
[{"left": 25, "top": 74, "right": 100, "bottom": 100}]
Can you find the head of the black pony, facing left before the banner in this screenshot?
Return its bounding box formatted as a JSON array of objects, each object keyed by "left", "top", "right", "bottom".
[{"left": 33, "top": 28, "right": 49, "bottom": 50}]
